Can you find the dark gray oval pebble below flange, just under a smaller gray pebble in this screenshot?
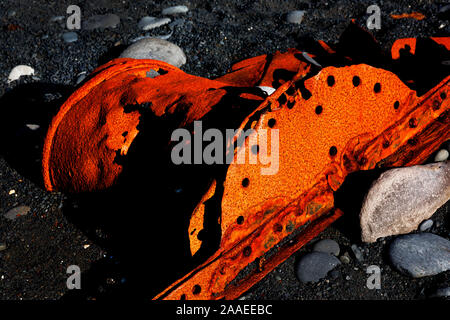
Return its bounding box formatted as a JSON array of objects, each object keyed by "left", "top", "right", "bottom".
[{"left": 296, "top": 252, "right": 340, "bottom": 283}]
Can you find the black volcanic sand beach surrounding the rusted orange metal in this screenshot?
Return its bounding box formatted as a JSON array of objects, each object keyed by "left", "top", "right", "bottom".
[{"left": 0, "top": 0, "right": 450, "bottom": 300}]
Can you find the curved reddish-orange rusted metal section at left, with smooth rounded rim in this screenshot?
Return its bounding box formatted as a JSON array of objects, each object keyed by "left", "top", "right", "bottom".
[{"left": 43, "top": 49, "right": 308, "bottom": 192}]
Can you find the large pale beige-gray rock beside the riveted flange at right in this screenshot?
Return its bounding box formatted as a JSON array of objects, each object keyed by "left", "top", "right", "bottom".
[{"left": 360, "top": 161, "right": 450, "bottom": 242}]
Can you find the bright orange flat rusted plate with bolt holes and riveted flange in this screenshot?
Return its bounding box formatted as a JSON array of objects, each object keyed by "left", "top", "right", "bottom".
[{"left": 160, "top": 64, "right": 450, "bottom": 299}]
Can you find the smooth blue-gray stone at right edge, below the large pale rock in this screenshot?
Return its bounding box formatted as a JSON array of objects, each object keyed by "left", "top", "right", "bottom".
[{"left": 389, "top": 233, "right": 450, "bottom": 278}]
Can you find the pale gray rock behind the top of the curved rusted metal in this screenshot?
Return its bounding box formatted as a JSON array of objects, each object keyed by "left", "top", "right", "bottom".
[{"left": 120, "top": 38, "right": 186, "bottom": 68}]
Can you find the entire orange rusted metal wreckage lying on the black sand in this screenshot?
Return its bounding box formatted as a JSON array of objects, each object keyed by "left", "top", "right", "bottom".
[{"left": 43, "top": 24, "right": 450, "bottom": 299}]
